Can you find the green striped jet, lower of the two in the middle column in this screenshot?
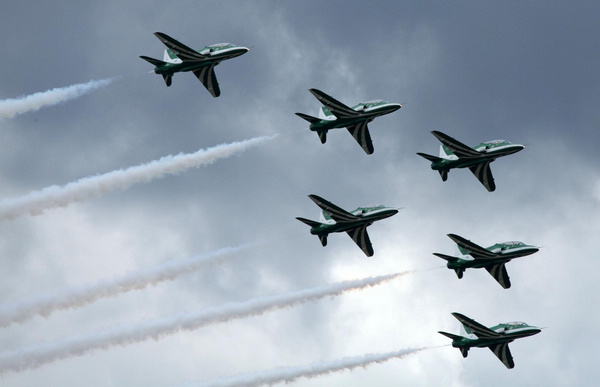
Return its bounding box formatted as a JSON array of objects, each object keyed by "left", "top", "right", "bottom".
[{"left": 296, "top": 195, "right": 399, "bottom": 257}]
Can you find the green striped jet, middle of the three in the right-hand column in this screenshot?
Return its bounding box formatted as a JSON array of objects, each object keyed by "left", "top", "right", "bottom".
[{"left": 433, "top": 234, "right": 540, "bottom": 289}]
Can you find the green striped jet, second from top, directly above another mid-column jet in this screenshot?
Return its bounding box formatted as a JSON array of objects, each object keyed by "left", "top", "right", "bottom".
[{"left": 296, "top": 89, "right": 402, "bottom": 155}]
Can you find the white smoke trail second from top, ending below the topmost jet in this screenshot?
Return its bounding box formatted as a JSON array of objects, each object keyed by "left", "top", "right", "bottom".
[{"left": 0, "top": 136, "right": 276, "bottom": 222}]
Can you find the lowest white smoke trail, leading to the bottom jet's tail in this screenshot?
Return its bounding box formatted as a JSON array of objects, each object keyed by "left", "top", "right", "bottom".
[{"left": 186, "top": 347, "right": 429, "bottom": 387}]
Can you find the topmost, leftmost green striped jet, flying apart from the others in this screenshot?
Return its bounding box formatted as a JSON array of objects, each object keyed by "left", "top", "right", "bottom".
[{"left": 140, "top": 32, "right": 249, "bottom": 98}]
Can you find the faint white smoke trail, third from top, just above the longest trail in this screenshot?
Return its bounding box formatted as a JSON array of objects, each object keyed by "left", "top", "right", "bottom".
[{"left": 0, "top": 245, "right": 249, "bottom": 327}]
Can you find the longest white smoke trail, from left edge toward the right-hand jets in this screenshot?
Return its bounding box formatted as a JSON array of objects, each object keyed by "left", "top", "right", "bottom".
[{"left": 0, "top": 272, "right": 408, "bottom": 374}]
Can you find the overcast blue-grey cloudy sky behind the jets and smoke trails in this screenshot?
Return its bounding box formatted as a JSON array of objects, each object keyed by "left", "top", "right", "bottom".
[{"left": 0, "top": 0, "right": 600, "bottom": 387}]
